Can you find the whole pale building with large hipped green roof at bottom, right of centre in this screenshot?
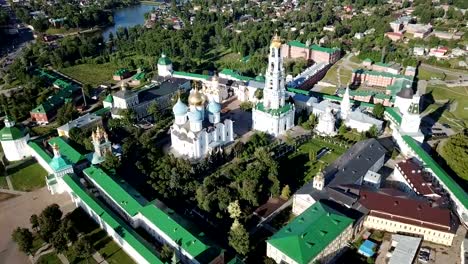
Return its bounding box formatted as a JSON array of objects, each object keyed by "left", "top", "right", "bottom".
[{"left": 267, "top": 202, "right": 353, "bottom": 264}]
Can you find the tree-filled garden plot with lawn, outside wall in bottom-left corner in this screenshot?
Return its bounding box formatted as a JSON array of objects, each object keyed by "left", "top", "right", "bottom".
[{"left": 12, "top": 204, "right": 135, "bottom": 264}]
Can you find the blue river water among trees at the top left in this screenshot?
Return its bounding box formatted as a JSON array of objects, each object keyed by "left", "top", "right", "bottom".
[{"left": 102, "top": 4, "right": 158, "bottom": 40}]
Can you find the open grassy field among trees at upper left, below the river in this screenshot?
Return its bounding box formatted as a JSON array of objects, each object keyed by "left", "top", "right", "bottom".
[{"left": 60, "top": 63, "right": 119, "bottom": 86}]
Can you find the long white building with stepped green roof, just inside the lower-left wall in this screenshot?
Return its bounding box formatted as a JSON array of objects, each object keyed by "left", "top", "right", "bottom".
[{"left": 83, "top": 166, "right": 220, "bottom": 263}]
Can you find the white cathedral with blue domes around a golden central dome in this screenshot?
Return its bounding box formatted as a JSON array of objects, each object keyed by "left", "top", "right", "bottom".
[{"left": 171, "top": 89, "right": 234, "bottom": 160}]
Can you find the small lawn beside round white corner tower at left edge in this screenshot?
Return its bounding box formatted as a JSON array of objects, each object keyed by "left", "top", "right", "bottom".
[{"left": 10, "top": 162, "right": 47, "bottom": 191}]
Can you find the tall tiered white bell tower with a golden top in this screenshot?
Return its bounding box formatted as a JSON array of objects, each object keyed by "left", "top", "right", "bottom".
[{"left": 252, "top": 35, "right": 295, "bottom": 137}]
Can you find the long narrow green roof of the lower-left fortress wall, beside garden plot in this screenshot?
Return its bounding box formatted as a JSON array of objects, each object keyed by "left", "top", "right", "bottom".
[{"left": 62, "top": 175, "right": 163, "bottom": 264}]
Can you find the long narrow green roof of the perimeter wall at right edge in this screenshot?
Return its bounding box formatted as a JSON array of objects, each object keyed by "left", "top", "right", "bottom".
[{"left": 403, "top": 135, "right": 468, "bottom": 208}]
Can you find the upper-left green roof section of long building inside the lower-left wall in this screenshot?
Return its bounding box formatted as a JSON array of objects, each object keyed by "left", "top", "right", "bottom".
[{"left": 83, "top": 166, "right": 142, "bottom": 216}]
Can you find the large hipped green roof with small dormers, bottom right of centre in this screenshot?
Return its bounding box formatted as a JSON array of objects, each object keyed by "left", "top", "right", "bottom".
[{"left": 267, "top": 202, "right": 353, "bottom": 264}]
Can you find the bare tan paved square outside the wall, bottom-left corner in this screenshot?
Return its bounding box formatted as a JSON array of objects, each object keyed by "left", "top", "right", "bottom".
[{"left": 0, "top": 187, "right": 75, "bottom": 264}]
